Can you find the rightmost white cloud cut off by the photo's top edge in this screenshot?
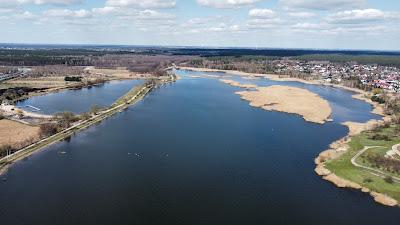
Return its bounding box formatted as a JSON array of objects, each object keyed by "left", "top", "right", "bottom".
[{"left": 279, "top": 0, "right": 366, "bottom": 10}]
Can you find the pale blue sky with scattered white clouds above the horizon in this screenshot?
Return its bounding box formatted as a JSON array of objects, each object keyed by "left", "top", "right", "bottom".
[{"left": 0, "top": 0, "right": 400, "bottom": 51}]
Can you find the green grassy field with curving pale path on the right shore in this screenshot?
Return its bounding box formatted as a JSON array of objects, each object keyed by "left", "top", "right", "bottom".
[{"left": 325, "top": 126, "right": 400, "bottom": 201}]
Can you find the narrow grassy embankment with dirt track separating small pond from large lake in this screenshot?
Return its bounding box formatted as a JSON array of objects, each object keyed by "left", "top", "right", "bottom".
[{"left": 0, "top": 76, "right": 174, "bottom": 176}]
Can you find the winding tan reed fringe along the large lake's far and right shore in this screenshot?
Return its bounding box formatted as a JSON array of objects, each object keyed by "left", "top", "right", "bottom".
[{"left": 178, "top": 67, "right": 400, "bottom": 207}]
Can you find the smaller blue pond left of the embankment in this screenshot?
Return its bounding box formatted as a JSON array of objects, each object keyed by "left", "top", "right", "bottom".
[{"left": 17, "top": 80, "right": 143, "bottom": 114}]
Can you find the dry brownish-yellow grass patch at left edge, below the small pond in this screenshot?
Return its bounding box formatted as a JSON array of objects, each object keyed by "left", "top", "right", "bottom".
[{"left": 0, "top": 119, "right": 40, "bottom": 148}]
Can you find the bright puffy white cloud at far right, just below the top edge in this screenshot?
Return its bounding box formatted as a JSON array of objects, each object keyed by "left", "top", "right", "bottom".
[{"left": 327, "top": 9, "right": 395, "bottom": 24}]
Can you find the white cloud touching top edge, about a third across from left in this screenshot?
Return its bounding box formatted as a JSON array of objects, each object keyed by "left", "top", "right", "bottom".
[{"left": 106, "top": 0, "right": 176, "bottom": 9}]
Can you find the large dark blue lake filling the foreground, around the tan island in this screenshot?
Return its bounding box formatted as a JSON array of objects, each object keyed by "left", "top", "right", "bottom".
[{"left": 0, "top": 71, "right": 400, "bottom": 225}]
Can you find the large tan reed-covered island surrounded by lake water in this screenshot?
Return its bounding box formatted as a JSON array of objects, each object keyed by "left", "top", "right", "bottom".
[{"left": 236, "top": 85, "right": 332, "bottom": 124}]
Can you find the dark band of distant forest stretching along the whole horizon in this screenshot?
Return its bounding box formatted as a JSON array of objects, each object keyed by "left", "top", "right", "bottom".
[{"left": 0, "top": 45, "right": 400, "bottom": 66}]
